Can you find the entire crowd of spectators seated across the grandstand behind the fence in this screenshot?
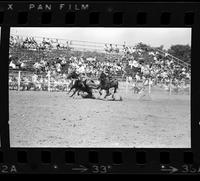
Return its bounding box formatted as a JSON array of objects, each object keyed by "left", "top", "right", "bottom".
[{"left": 9, "top": 37, "right": 191, "bottom": 92}]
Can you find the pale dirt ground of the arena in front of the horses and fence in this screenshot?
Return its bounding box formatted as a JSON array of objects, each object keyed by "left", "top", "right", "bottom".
[{"left": 9, "top": 83, "right": 191, "bottom": 148}]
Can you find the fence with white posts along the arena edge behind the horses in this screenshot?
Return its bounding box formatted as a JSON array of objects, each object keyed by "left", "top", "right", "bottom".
[{"left": 9, "top": 69, "right": 190, "bottom": 95}]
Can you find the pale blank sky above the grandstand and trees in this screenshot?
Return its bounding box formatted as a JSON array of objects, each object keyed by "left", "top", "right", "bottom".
[{"left": 11, "top": 27, "right": 191, "bottom": 49}]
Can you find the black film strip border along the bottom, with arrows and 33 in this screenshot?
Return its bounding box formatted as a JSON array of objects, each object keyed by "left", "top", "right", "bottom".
[{"left": 0, "top": 148, "right": 200, "bottom": 174}]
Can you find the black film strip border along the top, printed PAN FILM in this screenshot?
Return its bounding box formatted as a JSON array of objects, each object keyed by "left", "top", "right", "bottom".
[{"left": 0, "top": 2, "right": 199, "bottom": 27}]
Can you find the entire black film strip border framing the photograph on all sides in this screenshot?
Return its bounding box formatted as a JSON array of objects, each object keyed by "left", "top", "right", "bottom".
[{"left": 0, "top": 2, "right": 200, "bottom": 174}]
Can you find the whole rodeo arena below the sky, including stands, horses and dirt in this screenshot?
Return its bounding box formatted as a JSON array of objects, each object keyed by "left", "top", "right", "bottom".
[{"left": 9, "top": 34, "right": 191, "bottom": 148}]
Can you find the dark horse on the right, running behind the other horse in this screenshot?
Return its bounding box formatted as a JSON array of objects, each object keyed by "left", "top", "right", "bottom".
[{"left": 98, "top": 72, "right": 119, "bottom": 98}]
